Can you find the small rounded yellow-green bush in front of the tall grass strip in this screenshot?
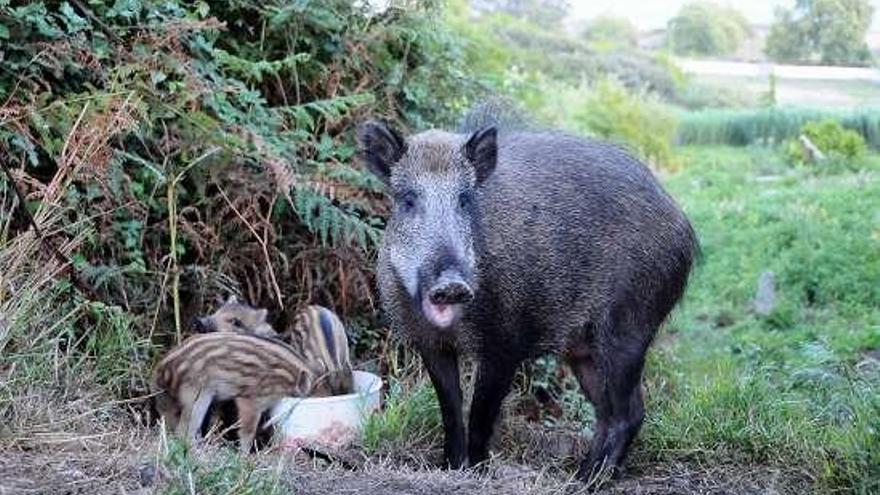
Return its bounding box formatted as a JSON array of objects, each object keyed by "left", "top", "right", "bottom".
[{"left": 785, "top": 119, "right": 866, "bottom": 163}]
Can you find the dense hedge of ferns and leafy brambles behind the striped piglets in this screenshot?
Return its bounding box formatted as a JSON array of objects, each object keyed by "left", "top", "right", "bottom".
[{"left": 0, "top": 0, "right": 482, "bottom": 392}]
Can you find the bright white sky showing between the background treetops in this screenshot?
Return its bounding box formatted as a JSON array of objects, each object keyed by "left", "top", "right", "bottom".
[{"left": 569, "top": 0, "right": 880, "bottom": 30}]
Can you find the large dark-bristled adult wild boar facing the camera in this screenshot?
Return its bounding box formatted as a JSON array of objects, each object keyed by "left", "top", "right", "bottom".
[{"left": 358, "top": 107, "right": 697, "bottom": 480}]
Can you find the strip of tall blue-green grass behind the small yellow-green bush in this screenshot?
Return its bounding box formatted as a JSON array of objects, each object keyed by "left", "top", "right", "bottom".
[{"left": 678, "top": 107, "right": 880, "bottom": 149}]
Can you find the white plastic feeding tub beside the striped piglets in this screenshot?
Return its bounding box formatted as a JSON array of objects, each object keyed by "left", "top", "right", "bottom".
[{"left": 268, "top": 371, "right": 382, "bottom": 447}]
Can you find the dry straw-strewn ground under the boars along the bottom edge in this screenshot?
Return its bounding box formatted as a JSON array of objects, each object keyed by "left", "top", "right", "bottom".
[{"left": 0, "top": 423, "right": 809, "bottom": 495}]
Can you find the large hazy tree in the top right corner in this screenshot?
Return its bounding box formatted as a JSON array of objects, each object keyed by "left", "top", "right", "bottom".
[{"left": 765, "top": 0, "right": 874, "bottom": 65}]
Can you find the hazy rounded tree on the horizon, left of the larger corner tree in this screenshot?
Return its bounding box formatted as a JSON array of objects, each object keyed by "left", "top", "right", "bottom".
[{"left": 668, "top": 2, "right": 749, "bottom": 55}]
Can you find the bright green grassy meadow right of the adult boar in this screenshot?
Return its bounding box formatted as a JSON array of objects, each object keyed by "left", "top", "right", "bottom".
[{"left": 641, "top": 148, "right": 880, "bottom": 493}]
